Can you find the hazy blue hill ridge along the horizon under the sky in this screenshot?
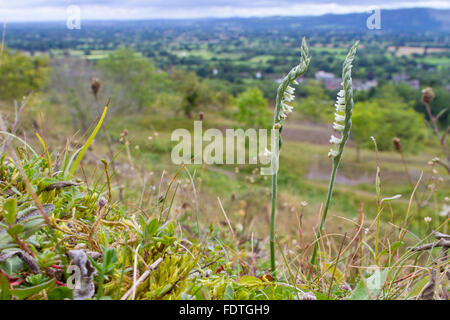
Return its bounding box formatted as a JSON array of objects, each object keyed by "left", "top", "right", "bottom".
[{"left": 9, "top": 8, "right": 450, "bottom": 33}]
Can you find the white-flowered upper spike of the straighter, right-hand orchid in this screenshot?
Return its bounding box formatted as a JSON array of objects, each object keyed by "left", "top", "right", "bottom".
[{"left": 328, "top": 42, "right": 358, "bottom": 161}]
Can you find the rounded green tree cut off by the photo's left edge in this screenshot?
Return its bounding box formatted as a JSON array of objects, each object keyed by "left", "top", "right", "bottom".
[{"left": 0, "top": 49, "right": 50, "bottom": 100}]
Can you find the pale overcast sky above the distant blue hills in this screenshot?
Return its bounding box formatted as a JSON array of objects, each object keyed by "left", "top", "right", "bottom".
[{"left": 0, "top": 0, "right": 450, "bottom": 22}]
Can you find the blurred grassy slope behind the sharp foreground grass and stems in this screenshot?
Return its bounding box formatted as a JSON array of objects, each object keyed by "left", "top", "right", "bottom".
[{"left": 2, "top": 92, "right": 449, "bottom": 298}]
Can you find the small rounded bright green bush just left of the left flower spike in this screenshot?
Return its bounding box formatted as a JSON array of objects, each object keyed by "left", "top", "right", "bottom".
[{"left": 236, "top": 87, "right": 271, "bottom": 128}]
